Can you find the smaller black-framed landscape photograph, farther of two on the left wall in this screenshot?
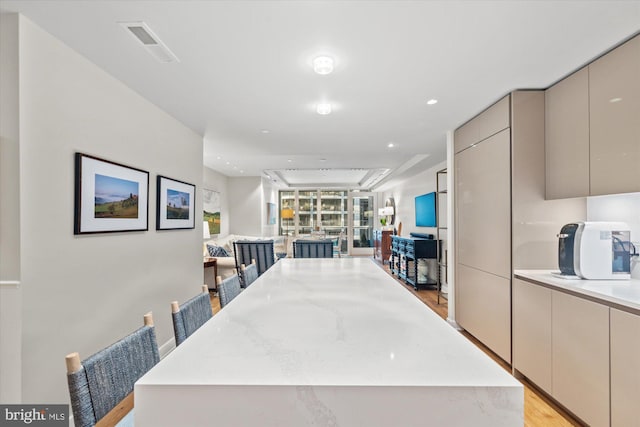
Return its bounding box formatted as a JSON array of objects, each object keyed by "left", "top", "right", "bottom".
[{"left": 156, "top": 175, "right": 196, "bottom": 230}]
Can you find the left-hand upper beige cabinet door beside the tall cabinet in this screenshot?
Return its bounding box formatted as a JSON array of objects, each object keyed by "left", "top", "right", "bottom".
[{"left": 544, "top": 67, "right": 589, "bottom": 199}]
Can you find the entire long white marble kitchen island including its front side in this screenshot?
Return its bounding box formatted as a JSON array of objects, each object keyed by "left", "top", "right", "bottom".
[{"left": 135, "top": 258, "right": 524, "bottom": 427}]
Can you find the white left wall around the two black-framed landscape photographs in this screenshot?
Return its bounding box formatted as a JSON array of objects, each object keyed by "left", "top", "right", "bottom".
[{"left": 5, "top": 17, "right": 202, "bottom": 403}]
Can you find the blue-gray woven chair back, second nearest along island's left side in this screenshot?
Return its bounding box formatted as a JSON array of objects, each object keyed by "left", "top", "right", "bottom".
[{"left": 171, "top": 285, "right": 213, "bottom": 346}]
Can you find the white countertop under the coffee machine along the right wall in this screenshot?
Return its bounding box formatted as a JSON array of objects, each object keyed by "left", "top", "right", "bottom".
[{"left": 514, "top": 270, "right": 640, "bottom": 314}]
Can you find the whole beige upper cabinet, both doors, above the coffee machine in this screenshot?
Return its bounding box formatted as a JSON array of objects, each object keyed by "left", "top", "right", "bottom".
[{"left": 545, "top": 36, "right": 640, "bottom": 199}]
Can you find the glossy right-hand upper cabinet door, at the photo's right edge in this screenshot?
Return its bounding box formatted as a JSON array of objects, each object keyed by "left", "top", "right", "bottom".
[{"left": 589, "top": 36, "right": 640, "bottom": 195}]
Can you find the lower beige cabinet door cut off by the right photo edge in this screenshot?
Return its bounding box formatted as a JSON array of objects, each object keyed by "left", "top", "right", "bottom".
[{"left": 611, "top": 308, "right": 640, "bottom": 427}]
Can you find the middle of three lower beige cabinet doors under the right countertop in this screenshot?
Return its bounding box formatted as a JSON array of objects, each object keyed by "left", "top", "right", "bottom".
[{"left": 551, "top": 291, "right": 609, "bottom": 427}]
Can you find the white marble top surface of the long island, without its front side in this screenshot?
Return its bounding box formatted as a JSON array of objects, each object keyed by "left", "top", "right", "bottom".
[{"left": 137, "top": 258, "right": 521, "bottom": 387}]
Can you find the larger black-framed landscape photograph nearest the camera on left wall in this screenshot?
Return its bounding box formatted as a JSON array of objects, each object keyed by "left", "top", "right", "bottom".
[{"left": 73, "top": 153, "right": 149, "bottom": 234}]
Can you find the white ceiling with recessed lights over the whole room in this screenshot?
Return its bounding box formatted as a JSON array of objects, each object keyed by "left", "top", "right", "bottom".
[{"left": 0, "top": 0, "right": 640, "bottom": 188}]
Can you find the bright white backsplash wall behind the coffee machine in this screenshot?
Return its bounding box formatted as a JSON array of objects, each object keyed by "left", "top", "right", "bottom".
[{"left": 587, "top": 193, "right": 640, "bottom": 279}]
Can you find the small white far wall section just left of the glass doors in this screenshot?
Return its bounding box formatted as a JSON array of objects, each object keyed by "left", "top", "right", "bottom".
[{"left": 227, "top": 176, "right": 265, "bottom": 236}]
